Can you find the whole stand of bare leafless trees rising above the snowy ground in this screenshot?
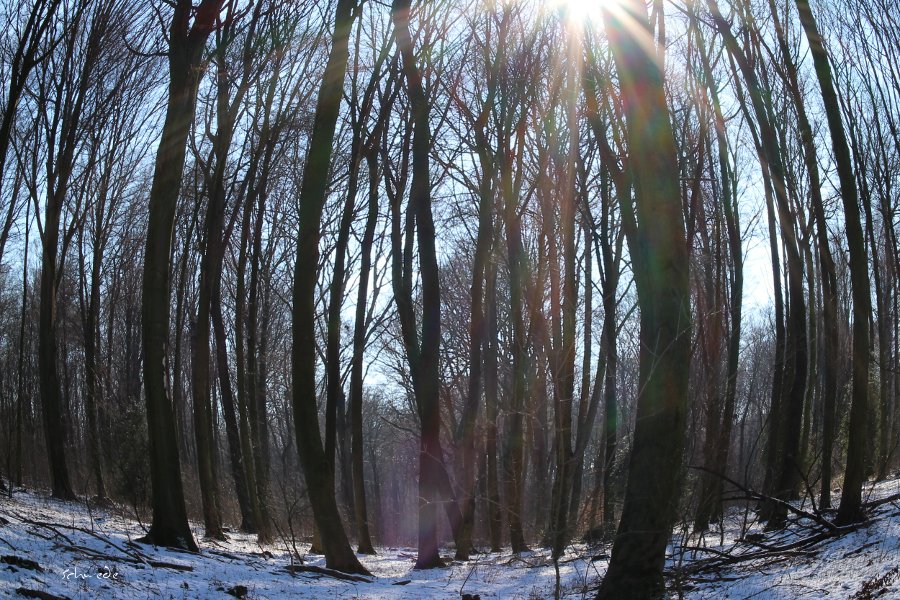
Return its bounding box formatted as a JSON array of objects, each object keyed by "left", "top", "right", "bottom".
[{"left": 0, "top": 0, "right": 900, "bottom": 598}]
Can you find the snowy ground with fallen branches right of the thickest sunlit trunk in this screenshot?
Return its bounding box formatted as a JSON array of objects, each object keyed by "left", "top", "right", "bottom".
[{"left": 669, "top": 477, "right": 900, "bottom": 600}]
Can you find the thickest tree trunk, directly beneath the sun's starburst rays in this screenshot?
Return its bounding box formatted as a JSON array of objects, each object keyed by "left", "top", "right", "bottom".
[{"left": 598, "top": 0, "right": 691, "bottom": 598}]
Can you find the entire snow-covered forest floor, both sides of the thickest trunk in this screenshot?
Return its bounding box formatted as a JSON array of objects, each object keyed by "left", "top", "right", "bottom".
[{"left": 0, "top": 478, "right": 900, "bottom": 600}]
